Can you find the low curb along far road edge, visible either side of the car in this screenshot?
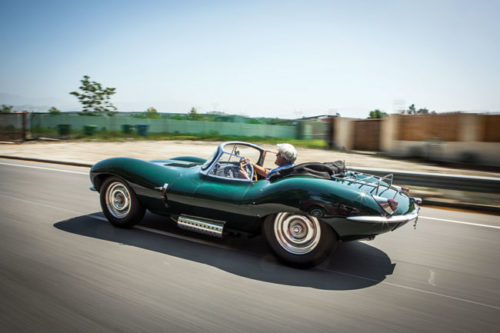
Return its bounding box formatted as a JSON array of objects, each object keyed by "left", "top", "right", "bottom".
[{"left": 0, "top": 155, "right": 500, "bottom": 214}]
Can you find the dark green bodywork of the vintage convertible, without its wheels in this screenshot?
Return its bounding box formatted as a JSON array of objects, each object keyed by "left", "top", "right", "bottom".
[{"left": 90, "top": 142, "right": 419, "bottom": 241}]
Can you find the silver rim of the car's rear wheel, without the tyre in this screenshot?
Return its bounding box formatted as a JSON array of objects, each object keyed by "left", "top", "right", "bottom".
[{"left": 274, "top": 213, "right": 321, "bottom": 254}]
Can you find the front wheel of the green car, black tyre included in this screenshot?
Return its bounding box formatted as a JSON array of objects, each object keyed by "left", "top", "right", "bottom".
[{"left": 100, "top": 177, "right": 145, "bottom": 228}]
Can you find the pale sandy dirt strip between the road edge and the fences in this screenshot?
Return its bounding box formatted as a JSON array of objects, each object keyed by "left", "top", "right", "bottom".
[{"left": 0, "top": 141, "right": 500, "bottom": 177}]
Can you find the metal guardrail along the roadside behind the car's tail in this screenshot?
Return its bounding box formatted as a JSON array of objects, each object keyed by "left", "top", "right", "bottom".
[{"left": 348, "top": 167, "right": 500, "bottom": 193}]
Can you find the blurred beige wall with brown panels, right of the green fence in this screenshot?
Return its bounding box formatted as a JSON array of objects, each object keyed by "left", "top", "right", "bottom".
[{"left": 331, "top": 113, "right": 500, "bottom": 166}]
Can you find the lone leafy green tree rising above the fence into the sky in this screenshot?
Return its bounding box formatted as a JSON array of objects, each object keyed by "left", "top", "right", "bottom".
[{"left": 70, "top": 75, "right": 116, "bottom": 115}]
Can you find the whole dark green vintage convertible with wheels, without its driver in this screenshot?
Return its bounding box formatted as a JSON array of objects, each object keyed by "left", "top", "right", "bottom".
[{"left": 90, "top": 142, "right": 420, "bottom": 267}]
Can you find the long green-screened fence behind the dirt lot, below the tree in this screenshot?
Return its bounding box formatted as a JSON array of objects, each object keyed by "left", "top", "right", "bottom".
[{"left": 0, "top": 112, "right": 331, "bottom": 141}]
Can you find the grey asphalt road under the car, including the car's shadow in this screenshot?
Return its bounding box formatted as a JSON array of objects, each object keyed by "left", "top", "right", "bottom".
[{"left": 0, "top": 159, "right": 500, "bottom": 333}]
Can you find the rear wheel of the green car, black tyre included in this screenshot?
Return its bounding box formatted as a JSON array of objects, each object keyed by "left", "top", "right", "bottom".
[{"left": 263, "top": 213, "right": 338, "bottom": 267}]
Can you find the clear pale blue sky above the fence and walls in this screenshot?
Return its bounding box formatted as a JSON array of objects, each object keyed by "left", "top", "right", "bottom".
[{"left": 0, "top": 0, "right": 500, "bottom": 117}]
